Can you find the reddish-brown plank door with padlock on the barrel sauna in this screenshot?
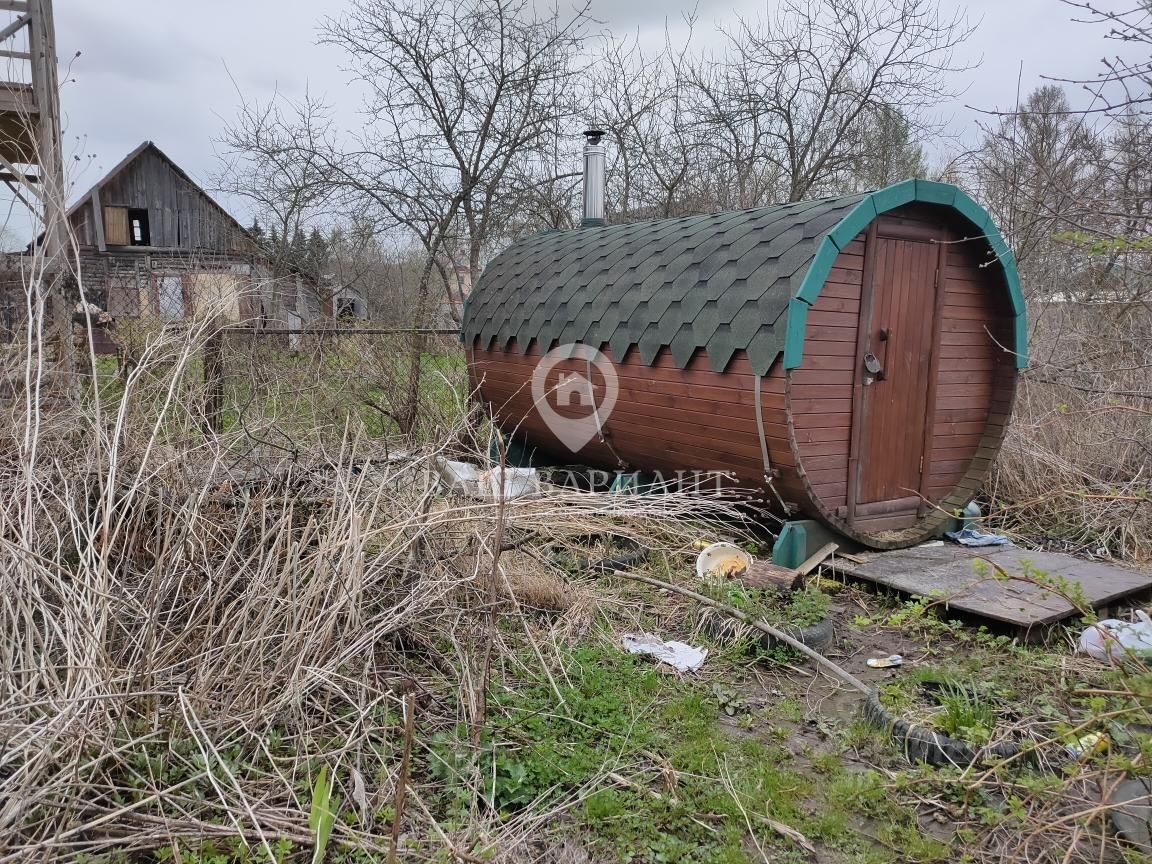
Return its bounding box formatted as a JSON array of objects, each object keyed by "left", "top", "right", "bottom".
[{"left": 854, "top": 235, "right": 941, "bottom": 511}]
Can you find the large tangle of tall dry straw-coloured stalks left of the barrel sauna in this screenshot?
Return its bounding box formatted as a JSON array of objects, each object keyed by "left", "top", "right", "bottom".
[{"left": 0, "top": 301, "right": 755, "bottom": 862}]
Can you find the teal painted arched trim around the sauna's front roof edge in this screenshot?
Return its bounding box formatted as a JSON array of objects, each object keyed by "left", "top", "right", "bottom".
[{"left": 783, "top": 180, "right": 1028, "bottom": 369}]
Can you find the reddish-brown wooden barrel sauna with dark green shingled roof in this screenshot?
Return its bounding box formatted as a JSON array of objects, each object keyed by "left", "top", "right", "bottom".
[{"left": 462, "top": 180, "right": 1028, "bottom": 548}]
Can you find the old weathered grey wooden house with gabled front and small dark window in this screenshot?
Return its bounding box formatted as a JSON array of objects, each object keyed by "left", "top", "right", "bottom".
[{"left": 68, "top": 142, "right": 279, "bottom": 321}]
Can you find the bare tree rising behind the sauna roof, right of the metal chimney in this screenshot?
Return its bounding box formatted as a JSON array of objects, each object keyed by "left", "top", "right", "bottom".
[{"left": 707, "top": 0, "right": 972, "bottom": 205}]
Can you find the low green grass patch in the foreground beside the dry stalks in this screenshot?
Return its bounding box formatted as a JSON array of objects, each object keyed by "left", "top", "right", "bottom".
[{"left": 410, "top": 642, "right": 947, "bottom": 864}]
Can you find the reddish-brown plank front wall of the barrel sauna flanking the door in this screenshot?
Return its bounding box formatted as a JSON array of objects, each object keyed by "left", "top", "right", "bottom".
[{"left": 787, "top": 206, "right": 1016, "bottom": 534}]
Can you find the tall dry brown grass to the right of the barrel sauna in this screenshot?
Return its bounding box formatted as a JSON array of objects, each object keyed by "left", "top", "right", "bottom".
[{"left": 990, "top": 304, "right": 1152, "bottom": 561}]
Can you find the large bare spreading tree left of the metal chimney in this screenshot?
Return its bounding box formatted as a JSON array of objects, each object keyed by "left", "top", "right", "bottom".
[{"left": 217, "top": 0, "right": 590, "bottom": 431}]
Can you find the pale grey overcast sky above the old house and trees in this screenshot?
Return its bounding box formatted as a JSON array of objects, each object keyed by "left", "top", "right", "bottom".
[{"left": 0, "top": 0, "right": 1124, "bottom": 244}]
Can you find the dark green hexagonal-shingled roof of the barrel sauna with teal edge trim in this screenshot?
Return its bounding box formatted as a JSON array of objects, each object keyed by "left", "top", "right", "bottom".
[{"left": 461, "top": 181, "right": 1023, "bottom": 374}]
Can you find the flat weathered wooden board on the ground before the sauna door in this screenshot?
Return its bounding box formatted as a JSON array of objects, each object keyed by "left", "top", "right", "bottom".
[{"left": 835, "top": 543, "right": 1152, "bottom": 628}]
